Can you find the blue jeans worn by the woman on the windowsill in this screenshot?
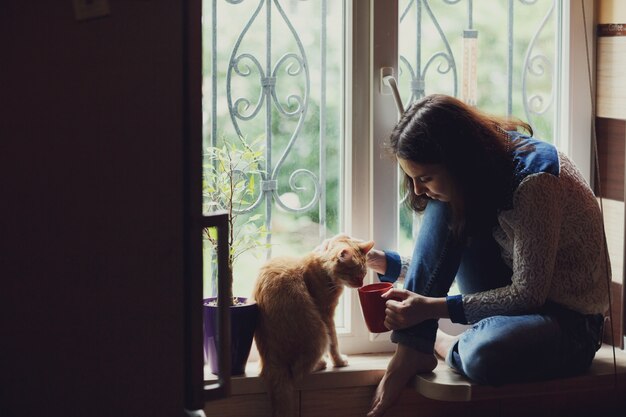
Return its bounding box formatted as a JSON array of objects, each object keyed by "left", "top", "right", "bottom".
[{"left": 391, "top": 201, "right": 603, "bottom": 385}]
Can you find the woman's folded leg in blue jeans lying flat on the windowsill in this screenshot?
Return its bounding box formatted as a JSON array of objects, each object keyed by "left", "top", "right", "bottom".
[{"left": 446, "top": 306, "right": 602, "bottom": 386}]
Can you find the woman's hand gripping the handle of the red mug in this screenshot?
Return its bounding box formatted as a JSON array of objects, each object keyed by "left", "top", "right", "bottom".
[{"left": 382, "top": 288, "right": 436, "bottom": 330}]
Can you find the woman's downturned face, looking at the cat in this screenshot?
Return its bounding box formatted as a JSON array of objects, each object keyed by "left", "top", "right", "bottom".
[{"left": 398, "top": 158, "right": 453, "bottom": 202}]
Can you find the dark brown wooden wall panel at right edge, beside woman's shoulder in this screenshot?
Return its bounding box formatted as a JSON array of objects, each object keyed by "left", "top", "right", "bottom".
[{"left": 594, "top": 118, "right": 626, "bottom": 201}]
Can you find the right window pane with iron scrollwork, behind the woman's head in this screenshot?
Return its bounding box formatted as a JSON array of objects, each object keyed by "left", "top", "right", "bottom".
[{"left": 398, "top": 0, "right": 559, "bottom": 254}]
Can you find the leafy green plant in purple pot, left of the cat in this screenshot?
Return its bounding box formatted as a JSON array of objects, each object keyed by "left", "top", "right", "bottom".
[{"left": 203, "top": 137, "right": 267, "bottom": 375}]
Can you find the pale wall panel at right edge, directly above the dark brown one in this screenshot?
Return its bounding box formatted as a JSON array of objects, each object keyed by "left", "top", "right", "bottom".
[{"left": 596, "top": 36, "right": 626, "bottom": 119}]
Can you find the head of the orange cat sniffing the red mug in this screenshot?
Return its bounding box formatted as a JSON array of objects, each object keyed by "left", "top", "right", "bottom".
[{"left": 327, "top": 236, "right": 374, "bottom": 288}]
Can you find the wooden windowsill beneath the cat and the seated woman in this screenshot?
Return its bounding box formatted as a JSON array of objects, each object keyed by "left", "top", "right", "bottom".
[{"left": 207, "top": 345, "right": 626, "bottom": 401}]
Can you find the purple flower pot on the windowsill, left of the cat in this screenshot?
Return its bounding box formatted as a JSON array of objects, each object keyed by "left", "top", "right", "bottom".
[{"left": 202, "top": 297, "right": 259, "bottom": 375}]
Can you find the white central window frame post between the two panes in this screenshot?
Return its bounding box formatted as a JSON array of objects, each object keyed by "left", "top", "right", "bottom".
[{"left": 339, "top": 0, "right": 398, "bottom": 353}]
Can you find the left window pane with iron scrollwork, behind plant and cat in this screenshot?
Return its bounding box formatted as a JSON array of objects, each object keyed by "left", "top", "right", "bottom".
[{"left": 203, "top": 0, "right": 344, "bottom": 302}]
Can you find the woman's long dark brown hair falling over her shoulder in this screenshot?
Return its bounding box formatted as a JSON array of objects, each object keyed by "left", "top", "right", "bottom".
[{"left": 387, "top": 94, "right": 533, "bottom": 239}]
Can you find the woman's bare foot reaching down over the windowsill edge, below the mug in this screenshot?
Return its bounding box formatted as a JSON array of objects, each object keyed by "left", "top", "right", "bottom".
[{"left": 367, "top": 344, "right": 437, "bottom": 417}]
